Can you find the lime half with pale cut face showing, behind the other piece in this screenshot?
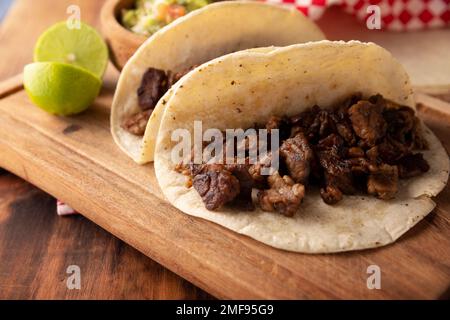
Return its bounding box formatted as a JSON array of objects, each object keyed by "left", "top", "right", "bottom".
[{"left": 34, "top": 22, "right": 108, "bottom": 78}]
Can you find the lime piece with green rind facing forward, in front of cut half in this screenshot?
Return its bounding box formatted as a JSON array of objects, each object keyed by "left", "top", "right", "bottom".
[{"left": 23, "top": 62, "right": 102, "bottom": 116}]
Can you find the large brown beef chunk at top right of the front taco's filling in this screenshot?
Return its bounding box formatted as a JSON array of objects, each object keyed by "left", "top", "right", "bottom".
[{"left": 348, "top": 100, "right": 387, "bottom": 147}]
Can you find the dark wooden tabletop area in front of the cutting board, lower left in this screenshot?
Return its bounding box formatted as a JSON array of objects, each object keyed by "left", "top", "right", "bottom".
[{"left": 0, "top": 175, "right": 213, "bottom": 299}]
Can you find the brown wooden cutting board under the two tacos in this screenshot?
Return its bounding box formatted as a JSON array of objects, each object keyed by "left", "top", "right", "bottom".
[{"left": 0, "top": 69, "right": 450, "bottom": 299}]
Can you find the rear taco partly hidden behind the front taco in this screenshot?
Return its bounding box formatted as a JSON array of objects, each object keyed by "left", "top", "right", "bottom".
[{"left": 111, "top": 1, "right": 324, "bottom": 164}]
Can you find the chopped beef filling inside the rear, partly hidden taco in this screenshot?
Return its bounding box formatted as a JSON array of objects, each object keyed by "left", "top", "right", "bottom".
[{"left": 121, "top": 66, "right": 196, "bottom": 136}]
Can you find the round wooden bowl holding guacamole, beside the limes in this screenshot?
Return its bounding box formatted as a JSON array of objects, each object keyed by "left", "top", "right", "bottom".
[{"left": 100, "top": 0, "right": 147, "bottom": 71}]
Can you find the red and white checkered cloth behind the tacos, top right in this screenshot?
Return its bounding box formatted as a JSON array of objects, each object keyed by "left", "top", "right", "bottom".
[{"left": 263, "top": 0, "right": 450, "bottom": 31}]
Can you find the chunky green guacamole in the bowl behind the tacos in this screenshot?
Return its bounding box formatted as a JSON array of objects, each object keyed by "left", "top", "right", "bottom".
[{"left": 121, "top": 0, "right": 214, "bottom": 36}]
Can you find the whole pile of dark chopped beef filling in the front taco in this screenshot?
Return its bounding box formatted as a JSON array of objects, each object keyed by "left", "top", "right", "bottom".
[{"left": 176, "top": 95, "right": 430, "bottom": 216}]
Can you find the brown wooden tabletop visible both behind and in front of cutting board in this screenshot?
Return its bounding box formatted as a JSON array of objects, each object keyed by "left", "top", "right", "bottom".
[{"left": 0, "top": 0, "right": 212, "bottom": 299}]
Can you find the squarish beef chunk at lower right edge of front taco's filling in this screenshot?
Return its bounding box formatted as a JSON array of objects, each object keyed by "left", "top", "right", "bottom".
[{"left": 367, "top": 164, "right": 398, "bottom": 200}]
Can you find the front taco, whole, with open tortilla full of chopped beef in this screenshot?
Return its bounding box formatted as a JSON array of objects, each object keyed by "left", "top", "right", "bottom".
[{"left": 155, "top": 41, "right": 449, "bottom": 253}]
